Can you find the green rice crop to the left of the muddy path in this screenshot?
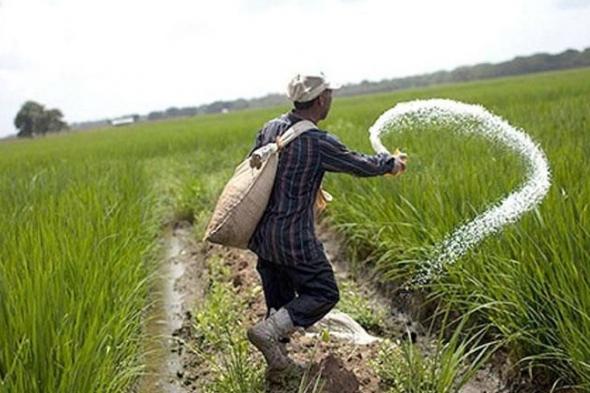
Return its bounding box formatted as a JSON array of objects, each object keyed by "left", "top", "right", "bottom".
[{"left": 0, "top": 112, "right": 260, "bottom": 393}]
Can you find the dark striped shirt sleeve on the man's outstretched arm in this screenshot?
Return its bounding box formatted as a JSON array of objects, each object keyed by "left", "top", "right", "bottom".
[{"left": 319, "top": 134, "right": 395, "bottom": 177}]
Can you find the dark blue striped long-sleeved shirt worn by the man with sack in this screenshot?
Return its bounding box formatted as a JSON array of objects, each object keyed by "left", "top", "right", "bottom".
[{"left": 249, "top": 113, "right": 394, "bottom": 265}]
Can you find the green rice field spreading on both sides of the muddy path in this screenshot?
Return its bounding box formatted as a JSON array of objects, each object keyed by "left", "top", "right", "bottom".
[{"left": 0, "top": 69, "right": 590, "bottom": 393}]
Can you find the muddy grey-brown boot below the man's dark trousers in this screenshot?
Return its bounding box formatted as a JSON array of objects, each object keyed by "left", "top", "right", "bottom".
[{"left": 248, "top": 308, "right": 297, "bottom": 380}]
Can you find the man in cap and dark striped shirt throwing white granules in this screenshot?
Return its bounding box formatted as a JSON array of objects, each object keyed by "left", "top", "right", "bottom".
[{"left": 248, "top": 74, "right": 405, "bottom": 380}]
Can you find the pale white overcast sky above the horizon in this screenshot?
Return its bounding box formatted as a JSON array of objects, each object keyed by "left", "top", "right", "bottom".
[{"left": 0, "top": 0, "right": 590, "bottom": 137}]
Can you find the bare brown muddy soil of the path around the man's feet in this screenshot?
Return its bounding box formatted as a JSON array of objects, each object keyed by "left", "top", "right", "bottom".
[{"left": 139, "top": 219, "right": 532, "bottom": 393}]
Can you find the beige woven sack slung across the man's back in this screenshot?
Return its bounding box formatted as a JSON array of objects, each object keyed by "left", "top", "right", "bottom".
[{"left": 205, "top": 120, "right": 316, "bottom": 248}]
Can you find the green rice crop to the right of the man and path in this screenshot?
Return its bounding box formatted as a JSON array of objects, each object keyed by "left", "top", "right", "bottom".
[{"left": 328, "top": 70, "right": 590, "bottom": 389}]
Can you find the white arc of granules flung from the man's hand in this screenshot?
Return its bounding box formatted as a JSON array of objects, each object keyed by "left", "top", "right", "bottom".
[{"left": 369, "top": 99, "right": 551, "bottom": 286}]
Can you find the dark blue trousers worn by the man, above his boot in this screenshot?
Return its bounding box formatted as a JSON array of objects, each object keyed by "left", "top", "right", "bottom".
[{"left": 256, "top": 257, "right": 340, "bottom": 328}]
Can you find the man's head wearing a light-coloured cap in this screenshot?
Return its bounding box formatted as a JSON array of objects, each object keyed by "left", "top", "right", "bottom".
[{"left": 287, "top": 73, "right": 338, "bottom": 121}]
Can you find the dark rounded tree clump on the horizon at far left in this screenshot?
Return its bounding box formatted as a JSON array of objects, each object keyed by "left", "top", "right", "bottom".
[{"left": 14, "top": 101, "right": 68, "bottom": 138}]
